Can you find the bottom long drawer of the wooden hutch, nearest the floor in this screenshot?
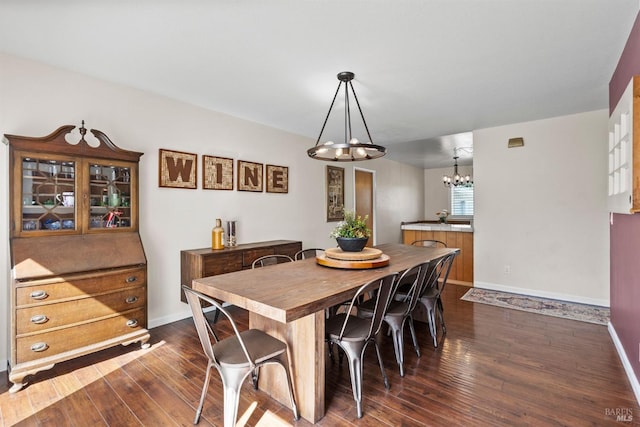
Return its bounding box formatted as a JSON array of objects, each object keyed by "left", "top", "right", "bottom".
[{"left": 16, "top": 308, "right": 146, "bottom": 363}]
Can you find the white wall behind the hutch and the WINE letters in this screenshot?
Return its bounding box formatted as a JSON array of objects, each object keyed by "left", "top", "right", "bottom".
[{"left": 0, "top": 54, "right": 424, "bottom": 369}]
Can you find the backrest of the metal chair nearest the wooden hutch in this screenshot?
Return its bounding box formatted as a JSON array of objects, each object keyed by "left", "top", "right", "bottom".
[{"left": 182, "top": 285, "right": 255, "bottom": 368}]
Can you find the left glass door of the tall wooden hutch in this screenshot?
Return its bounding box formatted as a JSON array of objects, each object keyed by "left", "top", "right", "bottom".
[{"left": 21, "top": 157, "right": 77, "bottom": 231}]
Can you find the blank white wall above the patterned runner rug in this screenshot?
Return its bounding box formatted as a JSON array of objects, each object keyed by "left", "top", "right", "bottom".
[{"left": 473, "top": 110, "right": 609, "bottom": 306}]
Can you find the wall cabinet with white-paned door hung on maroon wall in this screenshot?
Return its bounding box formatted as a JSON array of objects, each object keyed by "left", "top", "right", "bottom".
[{"left": 607, "top": 76, "right": 640, "bottom": 214}]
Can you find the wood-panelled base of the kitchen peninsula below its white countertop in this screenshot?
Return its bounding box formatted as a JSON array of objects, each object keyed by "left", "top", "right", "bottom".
[{"left": 402, "top": 230, "right": 473, "bottom": 286}]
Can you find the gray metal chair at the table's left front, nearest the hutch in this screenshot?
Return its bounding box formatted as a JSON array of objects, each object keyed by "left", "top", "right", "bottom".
[{"left": 182, "top": 286, "right": 300, "bottom": 427}]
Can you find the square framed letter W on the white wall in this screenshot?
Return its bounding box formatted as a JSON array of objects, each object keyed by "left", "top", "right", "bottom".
[{"left": 158, "top": 148, "right": 198, "bottom": 189}]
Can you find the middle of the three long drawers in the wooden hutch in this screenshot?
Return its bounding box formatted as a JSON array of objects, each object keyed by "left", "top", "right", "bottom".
[{"left": 16, "top": 287, "right": 147, "bottom": 336}]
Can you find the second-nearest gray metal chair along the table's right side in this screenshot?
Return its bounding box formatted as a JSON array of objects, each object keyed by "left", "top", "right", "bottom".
[{"left": 358, "top": 262, "right": 429, "bottom": 377}]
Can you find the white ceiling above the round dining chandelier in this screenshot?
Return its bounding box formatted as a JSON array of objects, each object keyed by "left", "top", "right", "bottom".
[{"left": 0, "top": 0, "right": 639, "bottom": 168}]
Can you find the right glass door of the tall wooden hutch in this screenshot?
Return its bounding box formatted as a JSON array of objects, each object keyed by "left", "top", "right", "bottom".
[{"left": 89, "top": 163, "right": 132, "bottom": 229}]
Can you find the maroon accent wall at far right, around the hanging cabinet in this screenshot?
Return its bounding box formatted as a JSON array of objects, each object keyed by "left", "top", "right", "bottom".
[{"left": 609, "top": 14, "right": 640, "bottom": 388}]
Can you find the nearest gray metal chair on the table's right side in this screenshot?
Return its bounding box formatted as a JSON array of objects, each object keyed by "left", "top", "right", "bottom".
[{"left": 325, "top": 273, "right": 398, "bottom": 418}]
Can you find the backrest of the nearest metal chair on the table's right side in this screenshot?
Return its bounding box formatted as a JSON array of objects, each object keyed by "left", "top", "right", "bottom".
[{"left": 339, "top": 273, "right": 398, "bottom": 340}]
